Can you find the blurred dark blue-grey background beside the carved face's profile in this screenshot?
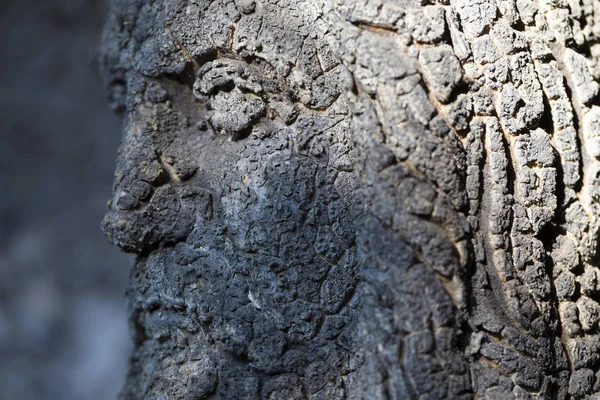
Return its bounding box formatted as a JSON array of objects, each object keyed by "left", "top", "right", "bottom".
[{"left": 0, "top": 0, "right": 133, "bottom": 400}]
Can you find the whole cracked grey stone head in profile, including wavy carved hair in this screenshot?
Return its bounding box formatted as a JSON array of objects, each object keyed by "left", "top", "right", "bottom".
[{"left": 101, "top": 0, "right": 600, "bottom": 399}]
